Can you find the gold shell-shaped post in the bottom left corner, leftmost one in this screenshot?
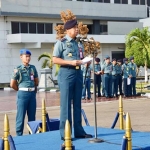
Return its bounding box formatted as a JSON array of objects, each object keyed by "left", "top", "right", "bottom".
[{"left": 4, "top": 114, "right": 10, "bottom": 150}]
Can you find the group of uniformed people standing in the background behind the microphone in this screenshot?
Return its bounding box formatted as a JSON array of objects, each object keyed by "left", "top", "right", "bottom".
[{"left": 82, "top": 56, "right": 137, "bottom": 100}]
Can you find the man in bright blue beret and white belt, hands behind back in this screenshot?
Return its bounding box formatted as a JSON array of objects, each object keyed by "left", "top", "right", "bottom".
[{"left": 10, "top": 49, "right": 39, "bottom": 136}]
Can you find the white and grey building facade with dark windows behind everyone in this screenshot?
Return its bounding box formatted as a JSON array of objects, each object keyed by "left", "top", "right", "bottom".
[{"left": 0, "top": 0, "right": 149, "bottom": 83}]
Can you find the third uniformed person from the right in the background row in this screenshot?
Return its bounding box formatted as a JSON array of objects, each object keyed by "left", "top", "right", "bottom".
[{"left": 117, "top": 59, "right": 123, "bottom": 95}]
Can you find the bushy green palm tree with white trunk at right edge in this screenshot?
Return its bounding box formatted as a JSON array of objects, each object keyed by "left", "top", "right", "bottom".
[{"left": 125, "top": 28, "right": 150, "bottom": 82}]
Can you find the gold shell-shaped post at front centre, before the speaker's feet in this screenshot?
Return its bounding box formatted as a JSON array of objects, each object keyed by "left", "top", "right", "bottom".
[{"left": 65, "top": 120, "right": 72, "bottom": 150}]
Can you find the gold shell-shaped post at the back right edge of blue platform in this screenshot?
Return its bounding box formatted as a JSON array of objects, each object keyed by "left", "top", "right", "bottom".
[{"left": 119, "top": 95, "right": 124, "bottom": 130}]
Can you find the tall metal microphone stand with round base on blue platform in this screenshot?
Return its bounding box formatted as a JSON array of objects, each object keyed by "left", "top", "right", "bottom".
[{"left": 89, "top": 52, "right": 104, "bottom": 143}]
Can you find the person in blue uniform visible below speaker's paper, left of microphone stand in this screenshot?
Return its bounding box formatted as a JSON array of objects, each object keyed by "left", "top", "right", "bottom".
[{"left": 81, "top": 61, "right": 92, "bottom": 100}]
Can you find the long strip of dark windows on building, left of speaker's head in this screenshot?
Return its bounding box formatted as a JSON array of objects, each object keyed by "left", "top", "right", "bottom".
[{"left": 11, "top": 22, "right": 53, "bottom": 34}]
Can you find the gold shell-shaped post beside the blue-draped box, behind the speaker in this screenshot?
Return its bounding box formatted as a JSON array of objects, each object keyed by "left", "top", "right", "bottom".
[{"left": 42, "top": 99, "right": 46, "bottom": 132}]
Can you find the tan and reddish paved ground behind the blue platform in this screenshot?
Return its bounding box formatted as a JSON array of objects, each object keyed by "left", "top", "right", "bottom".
[{"left": 0, "top": 91, "right": 150, "bottom": 137}]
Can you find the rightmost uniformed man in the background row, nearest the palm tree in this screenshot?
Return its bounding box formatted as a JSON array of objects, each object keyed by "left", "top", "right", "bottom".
[{"left": 129, "top": 56, "right": 137, "bottom": 96}]
